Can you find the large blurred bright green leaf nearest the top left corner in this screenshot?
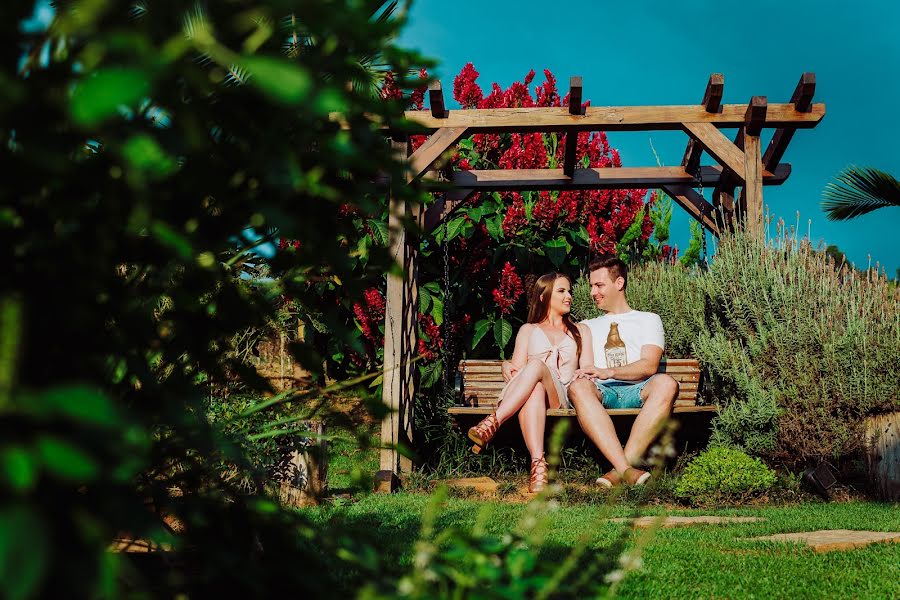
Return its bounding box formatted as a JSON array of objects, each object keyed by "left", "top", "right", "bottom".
[{"left": 69, "top": 68, "right": 150, "bottom": 127}]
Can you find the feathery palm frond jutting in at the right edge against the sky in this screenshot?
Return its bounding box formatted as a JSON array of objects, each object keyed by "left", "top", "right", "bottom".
[{"left": 822, "top": 166, "right": 900, "bottom": 221}]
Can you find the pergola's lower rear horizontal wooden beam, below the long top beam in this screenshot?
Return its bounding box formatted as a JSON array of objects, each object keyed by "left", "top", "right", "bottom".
[{"left": 451, "top": 163, "right": 791, "bottom": 191}]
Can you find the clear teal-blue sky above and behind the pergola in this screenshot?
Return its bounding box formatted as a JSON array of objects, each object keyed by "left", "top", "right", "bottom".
[{"left": 401, "top": 0, "right": 900, "bottom": 276}]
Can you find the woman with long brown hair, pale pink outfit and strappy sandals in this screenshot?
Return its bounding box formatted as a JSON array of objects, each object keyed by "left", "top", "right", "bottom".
[{"left": 469, "top": 272, "right": 594, "bottom": 493}]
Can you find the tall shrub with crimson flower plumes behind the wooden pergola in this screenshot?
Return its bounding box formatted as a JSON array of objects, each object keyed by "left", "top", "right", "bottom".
[{"left": 292, "top": 64, "right": 656, "bottom": 386}]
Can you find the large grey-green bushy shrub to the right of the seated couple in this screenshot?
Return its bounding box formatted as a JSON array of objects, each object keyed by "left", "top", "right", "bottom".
[{"left": 694, "top": 234, "right": 900, "bottom": 463}]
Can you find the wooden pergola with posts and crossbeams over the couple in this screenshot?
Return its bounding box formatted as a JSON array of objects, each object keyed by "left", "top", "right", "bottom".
[{"left": 378, "top": 73, "right": 825, "bottom": 489}]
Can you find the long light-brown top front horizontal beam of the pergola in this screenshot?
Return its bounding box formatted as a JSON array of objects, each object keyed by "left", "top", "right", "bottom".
[{"left": 331, "top": 103, "right": 825, "bottom": 133}]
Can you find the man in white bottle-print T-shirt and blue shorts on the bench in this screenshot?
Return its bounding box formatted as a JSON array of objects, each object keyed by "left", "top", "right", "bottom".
[{"left": 569, "top": 256, "right": 678, "bottom": 487}]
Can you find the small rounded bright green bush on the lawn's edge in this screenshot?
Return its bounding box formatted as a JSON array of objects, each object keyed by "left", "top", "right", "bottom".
[{"left": 675, "top": 446, "right": 776, "bottom": 505}]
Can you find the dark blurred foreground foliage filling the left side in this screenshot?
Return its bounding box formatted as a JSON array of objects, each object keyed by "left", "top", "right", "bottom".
[{"left": 0, "top": 0, "right": 430, "bottom": 597}]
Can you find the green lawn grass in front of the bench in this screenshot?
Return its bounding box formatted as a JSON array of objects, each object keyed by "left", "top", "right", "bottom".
[{"left": 306, "top": 493, "right": 900, "bottom": 598}]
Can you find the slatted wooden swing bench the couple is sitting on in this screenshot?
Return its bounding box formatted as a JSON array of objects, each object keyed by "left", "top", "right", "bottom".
[{"left": 448, "top": 358, "right": 718, "bottom": 417}]
